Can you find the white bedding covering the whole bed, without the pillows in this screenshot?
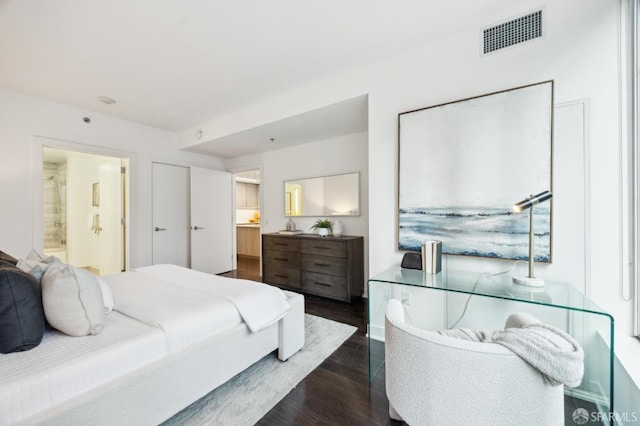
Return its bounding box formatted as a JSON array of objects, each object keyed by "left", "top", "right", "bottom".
[{"left": 0, "top": 265, "right": 304, "bottom": 425}]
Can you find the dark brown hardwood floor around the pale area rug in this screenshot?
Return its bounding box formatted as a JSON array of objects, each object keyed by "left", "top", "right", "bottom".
[{"left": 223, "top": 258, "right": 600, "bottom": 426}]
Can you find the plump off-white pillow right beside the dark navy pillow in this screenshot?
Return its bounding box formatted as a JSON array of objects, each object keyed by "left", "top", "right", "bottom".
[{"left": 42, "top": 263, "right": 105, "bottom": 336}]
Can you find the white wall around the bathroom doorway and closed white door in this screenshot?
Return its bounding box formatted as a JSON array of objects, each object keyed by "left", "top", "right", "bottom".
[{"left": 0, "top": 90, "right": 224, "bottom": 267}]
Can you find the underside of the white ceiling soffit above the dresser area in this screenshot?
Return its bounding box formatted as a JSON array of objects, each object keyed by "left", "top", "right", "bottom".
[{"left": 186, "top": 95, "right": 369, "bottom": 158}]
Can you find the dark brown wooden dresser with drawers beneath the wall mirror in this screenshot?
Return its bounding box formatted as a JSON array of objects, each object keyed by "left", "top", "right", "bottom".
[{"left": 262, "top": 233, "right": 364, "bottom": 302}]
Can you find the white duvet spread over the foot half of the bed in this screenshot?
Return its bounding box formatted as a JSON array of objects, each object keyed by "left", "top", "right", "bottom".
[{"left": 103, "top": 265, "right": 290, "bottom": 352}]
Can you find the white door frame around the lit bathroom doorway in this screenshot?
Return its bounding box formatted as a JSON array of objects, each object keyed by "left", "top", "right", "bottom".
[{"left": 31, "top": 135, "right": 132, "bottom": 270}]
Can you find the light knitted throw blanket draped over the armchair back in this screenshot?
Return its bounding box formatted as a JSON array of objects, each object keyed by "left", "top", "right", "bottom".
[{"left": 438, "top": 313, "right": 584, "bottom": 387}]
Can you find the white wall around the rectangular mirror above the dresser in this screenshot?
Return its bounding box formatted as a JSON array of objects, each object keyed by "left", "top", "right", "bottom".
[{"left": 226, "top": 132, "right": 369, "bottom": 275}]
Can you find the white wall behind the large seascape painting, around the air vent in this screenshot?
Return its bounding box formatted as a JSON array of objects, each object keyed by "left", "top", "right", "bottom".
[{"left": 195, "top": 0, "right": 640, "bottom": 414}]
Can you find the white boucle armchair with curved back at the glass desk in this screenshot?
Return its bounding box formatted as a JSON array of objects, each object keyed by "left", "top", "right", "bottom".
[{"left": 385, "top": 300, "right": 564, "bottom": 426}]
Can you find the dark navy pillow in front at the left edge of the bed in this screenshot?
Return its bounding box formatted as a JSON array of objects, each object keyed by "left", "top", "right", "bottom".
[{"left": 0, "top": 262, "right": 44, "bottom": 354}]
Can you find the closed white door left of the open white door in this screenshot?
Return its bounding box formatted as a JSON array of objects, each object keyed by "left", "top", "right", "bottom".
[{"left": 151, "top": 163, "right": 191, "bottom": 268}]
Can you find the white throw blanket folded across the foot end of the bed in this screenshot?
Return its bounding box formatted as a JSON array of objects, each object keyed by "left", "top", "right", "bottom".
[{"left": 134, "top": 265, "right": 291, "bottom": 333}]
